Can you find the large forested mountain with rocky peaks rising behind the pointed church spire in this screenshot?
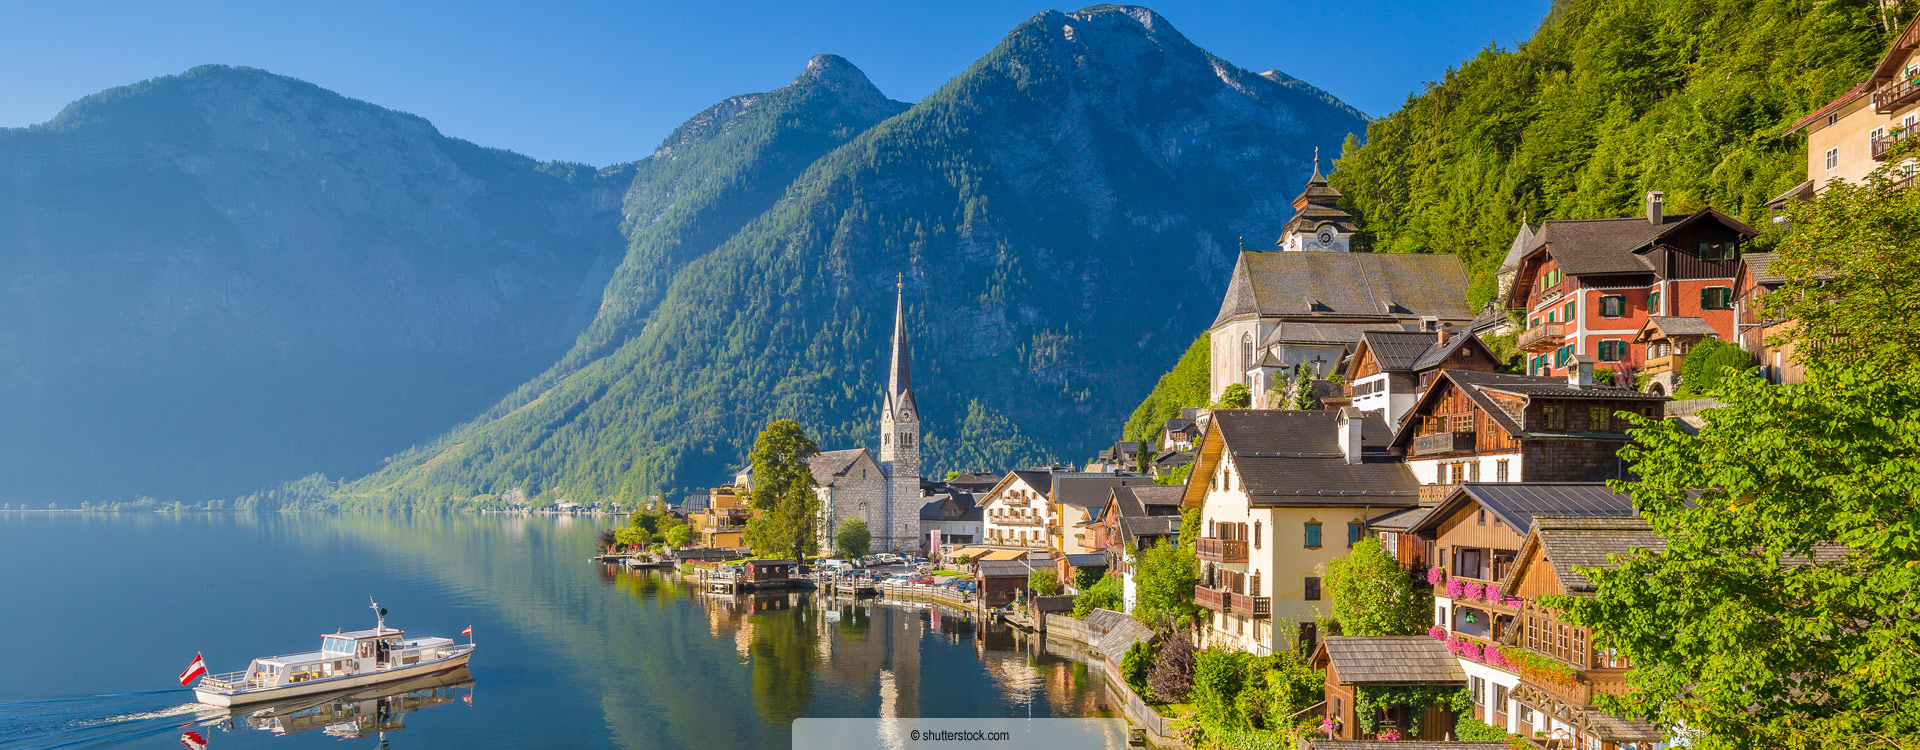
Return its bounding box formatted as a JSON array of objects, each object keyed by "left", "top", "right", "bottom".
[{"left": 348, "top": 6, "right": 1365, "bottom": 504}]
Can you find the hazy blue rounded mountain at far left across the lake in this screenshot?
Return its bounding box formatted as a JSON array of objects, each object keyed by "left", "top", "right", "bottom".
[{"left": 0, "top": 67, "right": 630, "bottom": 504}]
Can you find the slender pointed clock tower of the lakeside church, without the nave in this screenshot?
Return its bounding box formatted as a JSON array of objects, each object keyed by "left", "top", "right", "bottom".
[{"left": 872, "top": 278, "right": 920, "bottom": 552}]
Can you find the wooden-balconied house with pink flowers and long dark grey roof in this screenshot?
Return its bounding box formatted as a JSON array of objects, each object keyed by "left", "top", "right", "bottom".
[{"left": 1404, "top": 481, "right": 1638, "bottom": 733}]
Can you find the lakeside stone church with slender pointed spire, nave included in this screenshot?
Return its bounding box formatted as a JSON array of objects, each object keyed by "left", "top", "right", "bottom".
[{"left": 810, "top": 286, "right": 925, "bottom": 552}]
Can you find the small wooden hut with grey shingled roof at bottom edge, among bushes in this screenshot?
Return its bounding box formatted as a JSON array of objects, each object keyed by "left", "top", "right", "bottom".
[{"left": 1309, "top": 635, "right": 1466, "bottom": 746}]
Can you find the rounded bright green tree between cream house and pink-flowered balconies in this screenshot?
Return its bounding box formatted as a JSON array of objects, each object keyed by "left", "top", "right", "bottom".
[{"left": 1327, "top": 537, "right": 1432, "bottom": 635}]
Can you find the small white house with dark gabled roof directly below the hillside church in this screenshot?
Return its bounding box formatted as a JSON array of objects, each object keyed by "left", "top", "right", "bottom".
[{"left": 1344, "top": 324, "right": 1500, "bottom": 426}]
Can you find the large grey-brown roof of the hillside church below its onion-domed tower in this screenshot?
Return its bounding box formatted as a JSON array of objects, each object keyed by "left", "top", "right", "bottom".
[{"left": 1213, "top": 249, "right": 1473, "bottom": 326}]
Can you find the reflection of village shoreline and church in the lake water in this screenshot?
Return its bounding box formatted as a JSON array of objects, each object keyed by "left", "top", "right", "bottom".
[{"left": 603, "top": 566, "right": 1112, "bottom": 723}]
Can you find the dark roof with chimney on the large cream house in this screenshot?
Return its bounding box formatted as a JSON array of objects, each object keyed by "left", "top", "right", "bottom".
[{"left": 1213, "top": 409, "right": 1419, "bottom": 506}]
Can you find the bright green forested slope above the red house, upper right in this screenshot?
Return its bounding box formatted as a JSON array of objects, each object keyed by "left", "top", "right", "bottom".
[{"left": 1331, "top": 0, "right": 1910, "bottom": 305}]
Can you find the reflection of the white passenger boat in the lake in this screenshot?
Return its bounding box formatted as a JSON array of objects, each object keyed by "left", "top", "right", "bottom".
[{"left": 234, "top": 668, "right": 474, "bottom": 738}]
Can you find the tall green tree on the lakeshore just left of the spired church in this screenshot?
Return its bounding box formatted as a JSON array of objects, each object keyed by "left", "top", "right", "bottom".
[{"left": 747, "top": 420, "right": 820, "bottom": 560}]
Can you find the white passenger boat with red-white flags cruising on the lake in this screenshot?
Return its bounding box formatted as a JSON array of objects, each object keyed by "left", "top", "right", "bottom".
[{"left": 194, "top": 602, "right": 474, "bottom": 706}]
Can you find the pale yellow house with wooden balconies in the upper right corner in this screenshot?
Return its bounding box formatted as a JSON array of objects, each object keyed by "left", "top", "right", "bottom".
[{"left": 1774, "top": 17, "right": 1920, "bottom": 205}]
